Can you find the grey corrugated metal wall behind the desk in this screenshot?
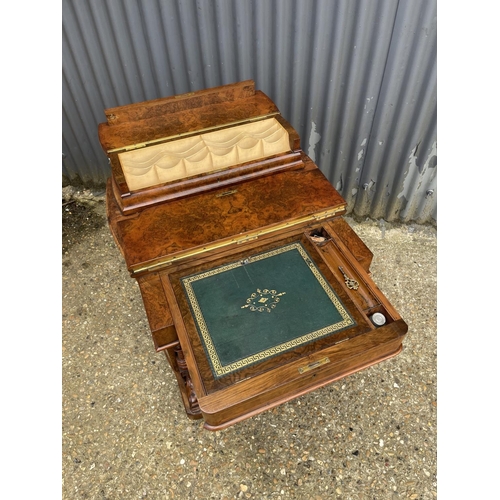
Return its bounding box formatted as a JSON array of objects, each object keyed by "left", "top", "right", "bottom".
[{"left": 62, "top": 0, "right": 437, "bottom": 222}]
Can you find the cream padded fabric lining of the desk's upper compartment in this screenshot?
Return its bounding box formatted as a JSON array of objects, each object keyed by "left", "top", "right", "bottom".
[{"left": 118, "top": 118, "right": 290, "bottom": 191}]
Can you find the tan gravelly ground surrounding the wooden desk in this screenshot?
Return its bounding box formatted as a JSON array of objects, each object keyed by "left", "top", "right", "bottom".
[{"left": 62, "top": 186, "right": 437, "bottom": 500}]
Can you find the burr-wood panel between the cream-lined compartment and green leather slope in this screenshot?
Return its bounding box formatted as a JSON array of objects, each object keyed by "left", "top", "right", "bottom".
[{"left": 108, "top": 155, "right": 346, "bottom": 274}]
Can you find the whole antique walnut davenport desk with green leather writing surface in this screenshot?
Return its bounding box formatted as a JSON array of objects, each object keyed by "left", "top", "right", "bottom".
[{"left": 99, "top": 81, "right": 407, "bottom": 430}]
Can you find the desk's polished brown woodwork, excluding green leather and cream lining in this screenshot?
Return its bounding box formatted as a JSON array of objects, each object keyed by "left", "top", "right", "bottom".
[{"left": 98, "top": 80, "right": 408, "bottom": 430}]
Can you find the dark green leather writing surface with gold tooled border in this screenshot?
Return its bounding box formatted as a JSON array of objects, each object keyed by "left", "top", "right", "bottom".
[{"left": 181, "top": 243, "right": 356, "bottom": 378}]
